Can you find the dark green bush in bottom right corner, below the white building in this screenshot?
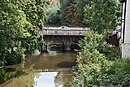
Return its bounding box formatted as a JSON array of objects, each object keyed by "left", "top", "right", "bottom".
[{"left": 108, "top": 59, "right": 130, "bottom": 87}]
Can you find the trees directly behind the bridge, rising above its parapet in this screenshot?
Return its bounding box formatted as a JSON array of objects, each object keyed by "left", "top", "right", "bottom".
[{"left": 44, "top": 0, "right": 90, "bottom": 26}]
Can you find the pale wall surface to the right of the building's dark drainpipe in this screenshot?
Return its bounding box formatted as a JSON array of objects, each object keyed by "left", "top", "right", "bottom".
[{"left": 122, "top": 0, "right": 130, "bottom": 58}]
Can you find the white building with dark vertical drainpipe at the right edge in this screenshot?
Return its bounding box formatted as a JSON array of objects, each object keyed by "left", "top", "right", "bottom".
[{"left": 121, "top": 0, "right": 130, "bottom": 58}]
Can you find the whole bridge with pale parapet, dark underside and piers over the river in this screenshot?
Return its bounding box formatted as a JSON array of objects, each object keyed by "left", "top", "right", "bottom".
[{"left": 41, "top": 26, "right": 90, "bottom": 51}]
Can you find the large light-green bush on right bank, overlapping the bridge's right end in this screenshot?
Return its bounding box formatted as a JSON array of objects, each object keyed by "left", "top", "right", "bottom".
[{"left": 73, "top": 31, "right": 123, "bottom": 87}]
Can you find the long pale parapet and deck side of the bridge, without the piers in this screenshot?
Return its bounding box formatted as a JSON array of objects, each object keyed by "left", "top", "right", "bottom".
[{"left": 42, "top": 28, "right": 89, "bottom": 36}]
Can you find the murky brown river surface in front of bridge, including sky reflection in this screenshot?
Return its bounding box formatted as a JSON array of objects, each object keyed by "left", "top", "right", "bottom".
[{"left": 0, "top": 53, "right": 76, "bottom": 87}]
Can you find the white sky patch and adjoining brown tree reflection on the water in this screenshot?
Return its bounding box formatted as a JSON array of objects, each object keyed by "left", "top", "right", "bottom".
[{"left": 34, "top": 72, "right": 73, "bottom": 87}]
